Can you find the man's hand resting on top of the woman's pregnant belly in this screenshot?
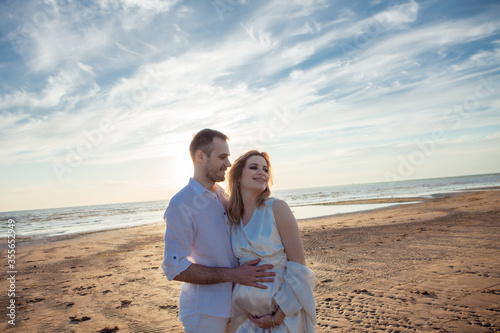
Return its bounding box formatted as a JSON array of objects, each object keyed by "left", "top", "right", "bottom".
[{"left": 231, "top": 259, "right": 276, "bottom": 289}]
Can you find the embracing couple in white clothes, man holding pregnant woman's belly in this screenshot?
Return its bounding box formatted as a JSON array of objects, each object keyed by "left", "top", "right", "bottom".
[{"left": 162, "top": 129, "right": 316, "bottom": 333}]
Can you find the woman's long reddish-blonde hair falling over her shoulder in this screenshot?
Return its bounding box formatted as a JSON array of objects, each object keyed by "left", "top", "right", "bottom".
[{"left": 227, "top": 150, "right": 273, "bottom": 223}]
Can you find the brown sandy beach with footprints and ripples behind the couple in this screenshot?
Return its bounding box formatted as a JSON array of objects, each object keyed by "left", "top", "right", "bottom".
[{"left": 0, "top": 189, "right": 500, "bottom": 332}]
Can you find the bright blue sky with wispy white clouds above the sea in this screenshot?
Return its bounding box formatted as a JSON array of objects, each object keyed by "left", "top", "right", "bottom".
[{"left": 0, "top": 0, "right": 500, "bottom": 211}]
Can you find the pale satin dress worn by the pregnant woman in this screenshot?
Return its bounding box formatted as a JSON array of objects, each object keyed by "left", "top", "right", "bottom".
[{"left": 230, "top": 198, "right": 315, "bottom": 333}]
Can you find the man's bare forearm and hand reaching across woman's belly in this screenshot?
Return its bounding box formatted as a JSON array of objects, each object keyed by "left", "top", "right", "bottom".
[{"left": 174, "top": 259, "right": 276, "bottom": 289}]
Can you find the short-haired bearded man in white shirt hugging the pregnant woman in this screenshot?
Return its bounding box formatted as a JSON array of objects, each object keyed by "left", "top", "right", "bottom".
[{"left": 161, "top": 129, "right": 275, "bottom": 333}]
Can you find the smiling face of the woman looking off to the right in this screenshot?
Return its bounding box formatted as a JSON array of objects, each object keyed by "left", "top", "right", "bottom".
[{"left": 240, "top": 155, "right": 269, "bottom": 193}]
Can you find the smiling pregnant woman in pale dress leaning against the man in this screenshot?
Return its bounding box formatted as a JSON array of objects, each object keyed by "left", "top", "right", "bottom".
[{"left": 227, "top": 150, "right": 316, "bottom": 333}]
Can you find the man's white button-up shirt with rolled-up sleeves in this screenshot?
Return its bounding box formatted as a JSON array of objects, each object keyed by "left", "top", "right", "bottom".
[{"left": 161, "top": 178, "right": 238, "bottom": 321}]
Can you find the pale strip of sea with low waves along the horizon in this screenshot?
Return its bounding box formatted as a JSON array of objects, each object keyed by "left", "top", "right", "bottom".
[{"left": 0, "top": 173, "right": 500, "bottom": 239}]
